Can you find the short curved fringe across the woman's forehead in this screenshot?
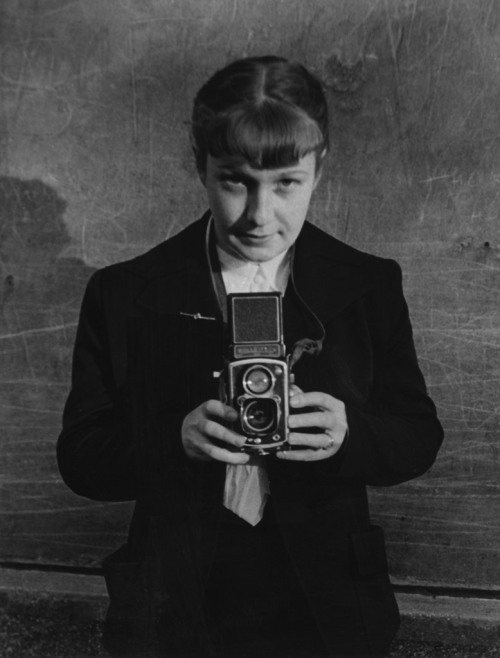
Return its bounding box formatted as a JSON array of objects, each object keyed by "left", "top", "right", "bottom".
[{"left": 206, "top": 100, "right": 326, "bottom": 169}]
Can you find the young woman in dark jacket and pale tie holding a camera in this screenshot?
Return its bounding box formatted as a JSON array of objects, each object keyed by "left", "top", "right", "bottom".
[{"left": 58, "top": 57, "right": 442, "bottom": 658}]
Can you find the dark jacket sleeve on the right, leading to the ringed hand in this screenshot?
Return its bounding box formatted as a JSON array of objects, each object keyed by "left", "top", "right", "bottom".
[{"left": 336, "top": 260, "right": 443, "bottom": 486}]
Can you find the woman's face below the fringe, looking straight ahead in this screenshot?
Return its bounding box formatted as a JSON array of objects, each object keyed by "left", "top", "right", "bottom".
[{"left": 200, "top": 153, "right": 319, "bottom": 263}]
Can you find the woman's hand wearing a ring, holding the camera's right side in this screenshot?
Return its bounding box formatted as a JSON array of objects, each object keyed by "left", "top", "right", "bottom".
[{"left": 277, "top": 386, "right": 347, "bottom": 461}]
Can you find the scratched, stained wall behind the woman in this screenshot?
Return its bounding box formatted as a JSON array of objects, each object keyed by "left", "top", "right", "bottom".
[{"left": 0, "top": 0, "right": 500, "bottom": 589}]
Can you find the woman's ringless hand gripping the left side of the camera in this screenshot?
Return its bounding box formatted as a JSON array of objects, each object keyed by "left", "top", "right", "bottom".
[{"left": 181, "top": 400, "right": 250, "bottom": 464}]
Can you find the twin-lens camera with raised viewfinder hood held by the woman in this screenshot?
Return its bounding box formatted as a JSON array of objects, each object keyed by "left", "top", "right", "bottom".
[{"left": 222, "top": 292, "right": 289, "bottom": 455}]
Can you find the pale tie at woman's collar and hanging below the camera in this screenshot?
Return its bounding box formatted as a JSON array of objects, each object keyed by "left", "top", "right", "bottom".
[{"left": 224, "top": 265, "right": 271, "bottom": 525}]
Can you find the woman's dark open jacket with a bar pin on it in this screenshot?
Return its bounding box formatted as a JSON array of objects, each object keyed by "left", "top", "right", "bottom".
[{"left": 58, "top": 216, "right": 442, "bottom": 656}]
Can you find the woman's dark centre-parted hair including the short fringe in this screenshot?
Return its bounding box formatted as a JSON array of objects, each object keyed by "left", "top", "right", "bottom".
[{"left": 191, "top": 56, "right": 329, "bottom": 171}]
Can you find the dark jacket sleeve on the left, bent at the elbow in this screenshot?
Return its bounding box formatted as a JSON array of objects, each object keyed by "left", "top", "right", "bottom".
[{"left": 57, "top": 271, "right": 141, "bottom": 501}]
